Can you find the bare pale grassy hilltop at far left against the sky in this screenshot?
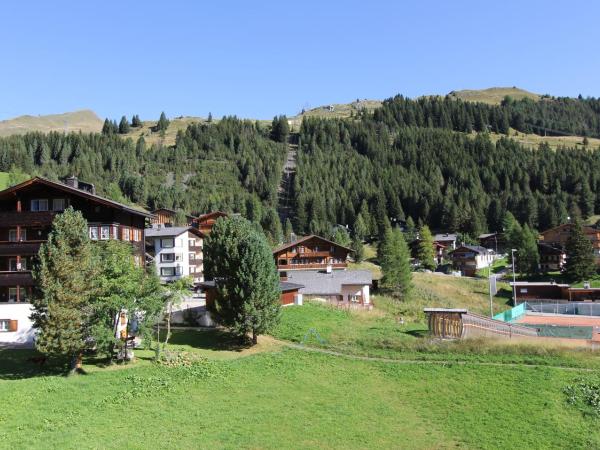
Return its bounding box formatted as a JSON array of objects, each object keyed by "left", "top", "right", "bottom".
[{"left": 0, "top": 109, "right": 103, "bottom": 136}]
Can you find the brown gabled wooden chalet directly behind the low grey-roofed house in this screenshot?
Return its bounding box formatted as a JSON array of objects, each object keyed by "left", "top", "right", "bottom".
[{"left": 273, "top": 235, "right": 352, "bottom": 271}]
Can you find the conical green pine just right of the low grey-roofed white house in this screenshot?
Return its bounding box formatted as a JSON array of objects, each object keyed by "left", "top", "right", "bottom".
[{"left": 380, "top": 228, "right": 412, "bottom": 297}]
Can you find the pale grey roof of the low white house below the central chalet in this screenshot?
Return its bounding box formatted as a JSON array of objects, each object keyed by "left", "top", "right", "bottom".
[{"left": 287, "top": 270, "right": 373, "bottom": 295}]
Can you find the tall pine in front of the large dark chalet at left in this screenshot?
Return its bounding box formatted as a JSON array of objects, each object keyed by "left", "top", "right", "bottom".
[{"left": 32, "top": 207, "right": 96, "bottom": 372}]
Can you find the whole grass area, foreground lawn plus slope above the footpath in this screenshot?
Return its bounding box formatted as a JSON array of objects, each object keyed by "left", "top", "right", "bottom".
[{"left": 0, "top": 284, "right": 600, "bottom": 449}]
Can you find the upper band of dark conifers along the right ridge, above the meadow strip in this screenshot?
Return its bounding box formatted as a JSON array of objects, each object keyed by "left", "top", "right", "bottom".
[{"left": 372, "top": 95, "right": 600, "bottom": 137}]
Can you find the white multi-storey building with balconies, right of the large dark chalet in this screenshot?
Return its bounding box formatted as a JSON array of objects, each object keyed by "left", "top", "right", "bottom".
[{"left": 146, "top": 224, "right": 205, "bottom": 283}]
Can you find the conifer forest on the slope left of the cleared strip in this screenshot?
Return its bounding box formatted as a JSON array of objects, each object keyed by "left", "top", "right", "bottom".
[{"left": 0, "top": 117, "right": 286, "bottom": 221}]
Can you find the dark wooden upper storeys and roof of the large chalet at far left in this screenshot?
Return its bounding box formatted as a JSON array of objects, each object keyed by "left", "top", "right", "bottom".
[{"left": 0, "top": 177, "right": 151, "bottom": 302}]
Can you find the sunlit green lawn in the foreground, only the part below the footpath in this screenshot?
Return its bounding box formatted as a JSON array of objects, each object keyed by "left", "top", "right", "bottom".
[{"left": 0, "top": 328, "right": 600, "bottom": 449}]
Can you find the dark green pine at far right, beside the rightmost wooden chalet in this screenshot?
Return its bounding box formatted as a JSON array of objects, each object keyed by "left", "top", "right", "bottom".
[{"left": 565, "top": 219, "right": 596, "bottom": 281}]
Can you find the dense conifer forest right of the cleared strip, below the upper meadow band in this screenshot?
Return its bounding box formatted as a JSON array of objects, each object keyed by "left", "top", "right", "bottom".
[{"left": 294, "top": 116, "right": 600, "bottom": 236}]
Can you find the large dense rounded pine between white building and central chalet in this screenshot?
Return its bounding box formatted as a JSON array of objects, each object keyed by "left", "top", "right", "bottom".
[{"left": 205, "top": 217, "right": 281, "bottom": 344}]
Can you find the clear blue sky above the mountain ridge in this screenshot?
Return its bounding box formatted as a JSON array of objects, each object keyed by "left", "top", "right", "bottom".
[{"left": 0, "top": 0, "right": 600, "bottom": 119}]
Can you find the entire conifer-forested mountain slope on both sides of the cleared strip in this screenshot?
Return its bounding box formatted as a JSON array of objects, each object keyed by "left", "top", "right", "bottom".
[{"left": 0, "top": 89, "right": 600, "bottom": 241}]
